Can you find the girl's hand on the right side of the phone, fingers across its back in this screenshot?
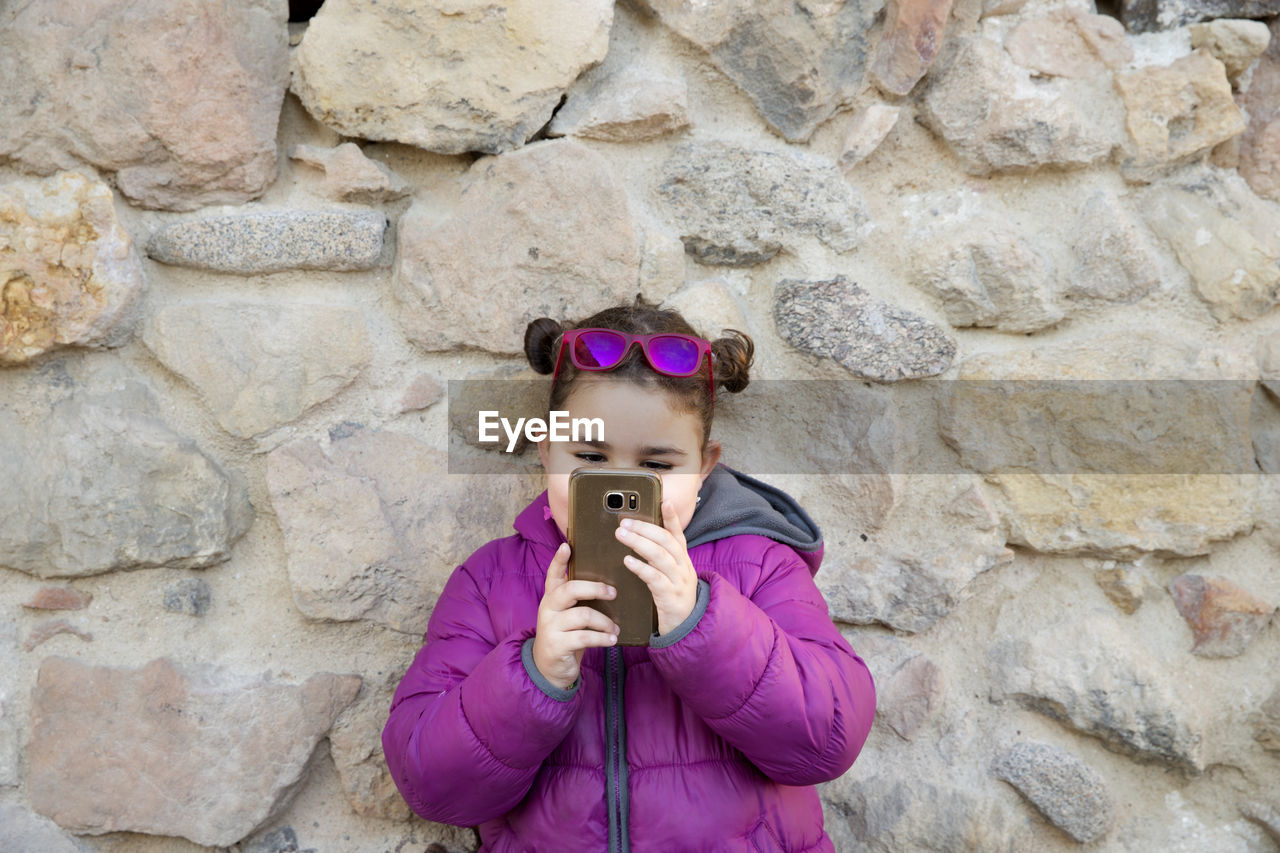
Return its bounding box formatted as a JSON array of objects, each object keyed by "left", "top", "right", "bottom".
[{"left": 616, "top": 501, "right": 698, "bottom": 634}]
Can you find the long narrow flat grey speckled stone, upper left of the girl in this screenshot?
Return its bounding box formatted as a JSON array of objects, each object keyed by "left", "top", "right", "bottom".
[{"left": 147, "top": 210, "right": 387, "bottom": 275}]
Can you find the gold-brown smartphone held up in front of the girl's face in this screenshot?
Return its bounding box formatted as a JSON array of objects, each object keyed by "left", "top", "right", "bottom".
[{"left": 568, "top": 467, "right": 662, "bottom": 646}]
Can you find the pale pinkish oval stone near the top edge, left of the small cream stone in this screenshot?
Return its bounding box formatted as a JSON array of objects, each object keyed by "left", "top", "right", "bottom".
[{"left": 1005, "top": 9, "right": 1133, "bottom": 77}]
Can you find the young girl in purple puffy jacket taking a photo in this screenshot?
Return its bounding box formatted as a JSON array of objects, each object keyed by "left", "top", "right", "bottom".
[{"left": 383, "top": 304, "right": 876, "bottom": 853}]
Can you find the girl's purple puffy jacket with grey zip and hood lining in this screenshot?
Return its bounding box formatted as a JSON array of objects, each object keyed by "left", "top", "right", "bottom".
[{"left": 383, "top": 466, "right": 876, "bottom": 853}]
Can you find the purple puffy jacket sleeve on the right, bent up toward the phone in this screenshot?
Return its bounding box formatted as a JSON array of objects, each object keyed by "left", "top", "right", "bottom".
[{"left": 649, "top": 543, "right": 876, "bottom": 785}]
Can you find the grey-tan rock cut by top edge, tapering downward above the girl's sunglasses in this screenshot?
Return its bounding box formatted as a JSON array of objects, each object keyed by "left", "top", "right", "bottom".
[{"left": 627, "top": 0, "right": 882, "bottom": 142}]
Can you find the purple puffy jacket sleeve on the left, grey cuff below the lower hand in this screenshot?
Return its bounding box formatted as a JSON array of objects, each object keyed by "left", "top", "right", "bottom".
[{"left": 383, "top": 550, "right": 582, "bottom": 826}]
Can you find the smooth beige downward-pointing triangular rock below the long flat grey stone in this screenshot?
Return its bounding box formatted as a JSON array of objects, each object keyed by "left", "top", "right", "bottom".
[{"left": 143, "top": 301, "right": 371, "bottom": 438}]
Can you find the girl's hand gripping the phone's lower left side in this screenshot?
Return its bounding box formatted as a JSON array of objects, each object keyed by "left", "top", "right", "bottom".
[{"left": 534, "top": 543, "right": 618, "bottom": 690}]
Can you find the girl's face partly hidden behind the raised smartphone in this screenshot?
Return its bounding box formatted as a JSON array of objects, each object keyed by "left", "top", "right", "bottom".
[{"left": 538, "top": 377, "right": 721, "bottom": 533}]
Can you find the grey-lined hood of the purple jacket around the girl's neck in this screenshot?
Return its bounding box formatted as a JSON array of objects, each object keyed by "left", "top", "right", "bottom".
[{"left": 512, "top": 465, "right": 823, "bottom": 574}]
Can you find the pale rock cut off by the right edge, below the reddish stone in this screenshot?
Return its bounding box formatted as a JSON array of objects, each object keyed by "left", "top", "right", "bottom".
[{"left": 1142, "top": 172, "right": 1280, "bottom": 320}]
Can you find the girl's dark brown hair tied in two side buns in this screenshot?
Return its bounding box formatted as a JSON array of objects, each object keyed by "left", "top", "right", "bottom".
[{"left": 525, "top": 297, "right": 755, "bottom": 447}]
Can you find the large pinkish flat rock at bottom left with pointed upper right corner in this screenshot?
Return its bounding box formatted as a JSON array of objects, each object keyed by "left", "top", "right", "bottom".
[{"left": 27, "top": 657, "right": 360, "bottom": 847}]
